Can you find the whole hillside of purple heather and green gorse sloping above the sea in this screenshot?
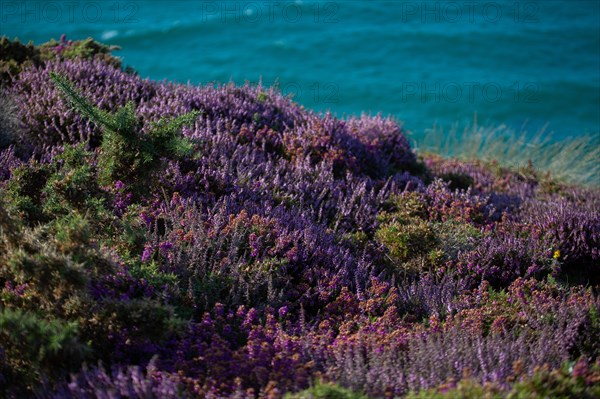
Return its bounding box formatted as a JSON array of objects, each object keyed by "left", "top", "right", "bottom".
[{"left": 0, "top": 38, "right": 600, "bottom": 398}]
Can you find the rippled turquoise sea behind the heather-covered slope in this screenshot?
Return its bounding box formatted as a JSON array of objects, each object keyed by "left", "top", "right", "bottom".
[{"left": 0, "top": 0, "right": 600, "bottom": 138}]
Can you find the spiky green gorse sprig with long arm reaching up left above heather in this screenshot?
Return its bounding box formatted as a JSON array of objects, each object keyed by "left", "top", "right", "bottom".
[{"left": 51, "top": 73, "right": 200, "bottom": 187}]
